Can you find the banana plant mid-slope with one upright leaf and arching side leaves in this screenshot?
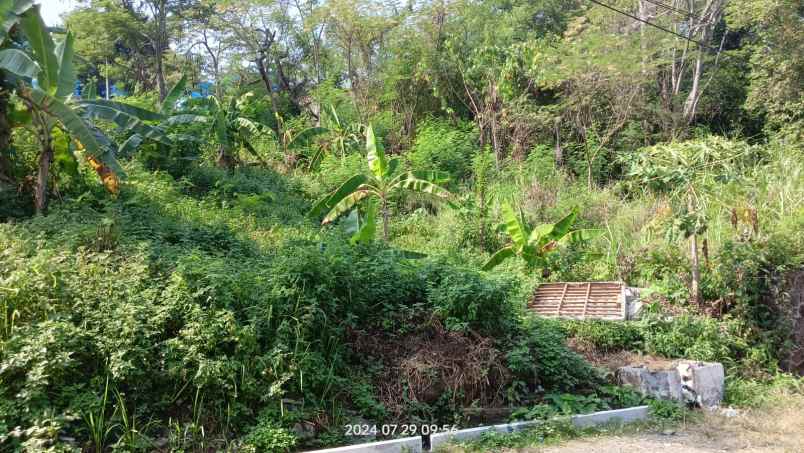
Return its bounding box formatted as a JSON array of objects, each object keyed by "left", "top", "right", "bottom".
[{"left": 308, "top": 125, "right": 451, "bottom": 241}]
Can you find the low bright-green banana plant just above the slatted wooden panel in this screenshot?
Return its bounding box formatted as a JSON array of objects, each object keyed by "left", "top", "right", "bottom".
[{"left": 483, "top": 204, "right": 600, "bottom": 270}]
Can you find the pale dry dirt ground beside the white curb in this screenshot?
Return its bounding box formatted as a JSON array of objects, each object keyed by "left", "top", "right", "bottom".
[{"left": 522, "top": 397, "right": 804, "bottom": 453}]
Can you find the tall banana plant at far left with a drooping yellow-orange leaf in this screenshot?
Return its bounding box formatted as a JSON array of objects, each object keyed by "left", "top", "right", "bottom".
[{"left": 0, "top": 1, "right": 124, "bottom": 214}]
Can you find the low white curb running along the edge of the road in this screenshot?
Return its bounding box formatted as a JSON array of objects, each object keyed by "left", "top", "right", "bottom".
[{"left": 308, "top": 406, "right": 650, "bottom": 453}]
